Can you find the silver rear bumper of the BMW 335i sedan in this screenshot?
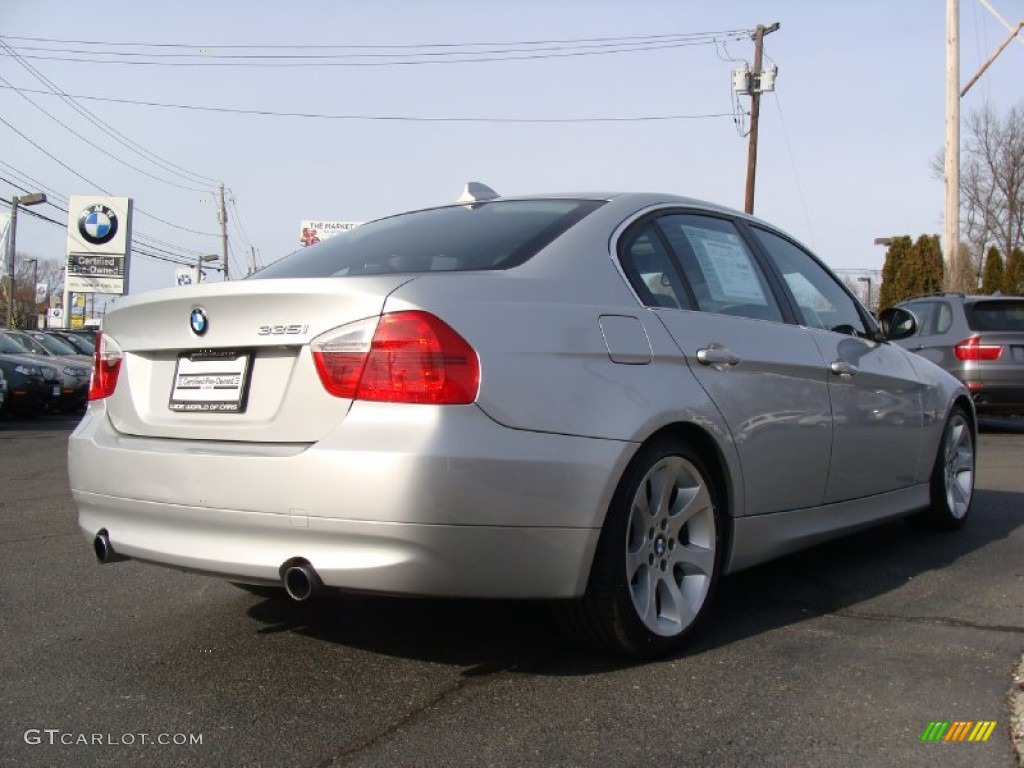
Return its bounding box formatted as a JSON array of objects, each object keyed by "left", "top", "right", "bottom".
[{"left": 69, "top": 402, "right": 635, "bottom": 598}]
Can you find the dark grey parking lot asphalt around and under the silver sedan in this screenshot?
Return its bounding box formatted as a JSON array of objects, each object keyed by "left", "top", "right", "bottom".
[{"left": 0, "top": 416, "right": 1024, "bottom": 767}]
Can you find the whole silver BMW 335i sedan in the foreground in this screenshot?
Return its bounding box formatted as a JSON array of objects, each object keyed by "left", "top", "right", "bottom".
[{"left": 69, "top": 188, "right": 976, "bottom": 656}]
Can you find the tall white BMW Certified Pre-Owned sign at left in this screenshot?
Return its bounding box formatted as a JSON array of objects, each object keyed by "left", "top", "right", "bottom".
[{"left": 66, "top": 196, "right": 132, "bottom": 294}]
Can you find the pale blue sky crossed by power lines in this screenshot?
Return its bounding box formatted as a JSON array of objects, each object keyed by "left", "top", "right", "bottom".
[{"left": 0, "top": 0, "right": 1024, "bottom": 301}]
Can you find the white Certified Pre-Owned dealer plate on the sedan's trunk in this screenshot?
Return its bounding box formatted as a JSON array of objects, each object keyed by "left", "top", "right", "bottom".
[{"left": 168, "top": 349, "right": 252, "bottom": 414}]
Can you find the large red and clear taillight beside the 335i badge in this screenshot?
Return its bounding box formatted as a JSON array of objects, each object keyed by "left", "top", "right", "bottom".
[{"left": 310, "top": 311, "right": 480, "bottom": 406}]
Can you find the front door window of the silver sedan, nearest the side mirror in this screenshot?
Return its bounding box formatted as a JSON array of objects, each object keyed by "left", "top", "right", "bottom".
[{"left": 753, "top": 227, "right": 868, "bottom": 336}]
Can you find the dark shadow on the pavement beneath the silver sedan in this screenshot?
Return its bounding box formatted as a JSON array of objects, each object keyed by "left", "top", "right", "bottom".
[{"left": 249, "top": 490, "right": 1024, "bottom": 677}]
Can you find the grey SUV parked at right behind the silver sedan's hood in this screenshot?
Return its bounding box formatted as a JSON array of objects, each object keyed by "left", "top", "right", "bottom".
[{"left": 882, "top": 293, "right": 1024, "bottom": 416}]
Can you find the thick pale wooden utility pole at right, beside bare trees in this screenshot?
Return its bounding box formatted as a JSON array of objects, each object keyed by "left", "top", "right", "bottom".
[{"left": 942, "top": 0, "right": 963, "bottom": 288}]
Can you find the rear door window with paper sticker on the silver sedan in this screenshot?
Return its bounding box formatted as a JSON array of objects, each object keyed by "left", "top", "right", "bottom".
[{"left": 657, "top": 214, "right": 782, "bottom": 323}]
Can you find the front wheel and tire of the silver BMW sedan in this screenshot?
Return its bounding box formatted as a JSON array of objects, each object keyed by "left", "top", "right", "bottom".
[{"left": 908, "top": 406, "right": 975, "bottom": 530}]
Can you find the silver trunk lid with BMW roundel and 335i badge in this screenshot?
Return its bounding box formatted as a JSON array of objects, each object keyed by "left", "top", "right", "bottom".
[{"left": 103, "top": 274, "right": 410, "bottom": 442}]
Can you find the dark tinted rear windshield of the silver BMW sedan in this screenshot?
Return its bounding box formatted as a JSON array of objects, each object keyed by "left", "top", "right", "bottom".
[{"left": 252, "top": 200, "right": 602, "bottom": 280}]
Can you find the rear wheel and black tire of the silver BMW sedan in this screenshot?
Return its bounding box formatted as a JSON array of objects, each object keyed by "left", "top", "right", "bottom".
[{"left": 553, "top": 438, "right": 724, "bottom": 658}]
